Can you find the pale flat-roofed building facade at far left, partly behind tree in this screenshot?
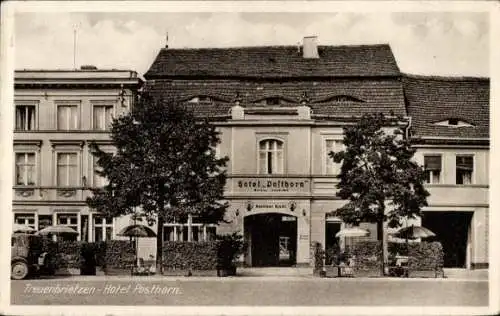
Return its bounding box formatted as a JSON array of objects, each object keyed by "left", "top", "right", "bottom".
[{"left": 12, "top": 67, "right": 142, "bottom": 241}]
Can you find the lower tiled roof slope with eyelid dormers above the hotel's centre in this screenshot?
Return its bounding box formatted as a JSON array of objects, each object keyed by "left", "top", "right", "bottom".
[{"left": 147, "top": 78, "right": 406, "bottom": 117}]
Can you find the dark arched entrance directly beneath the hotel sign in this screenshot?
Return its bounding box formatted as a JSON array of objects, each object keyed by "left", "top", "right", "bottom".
[{"left": 244, "top": 213, "right": 297, "bottom": 267}]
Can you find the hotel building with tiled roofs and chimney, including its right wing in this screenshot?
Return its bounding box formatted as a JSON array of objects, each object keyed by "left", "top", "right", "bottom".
[{"left": 145, "top": 37, "right": 489, "bottom": 267}]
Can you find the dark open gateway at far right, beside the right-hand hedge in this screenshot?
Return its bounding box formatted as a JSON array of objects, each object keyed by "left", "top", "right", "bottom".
[{"left": 422, "top": 212, "right": 472, "bottom": 268}]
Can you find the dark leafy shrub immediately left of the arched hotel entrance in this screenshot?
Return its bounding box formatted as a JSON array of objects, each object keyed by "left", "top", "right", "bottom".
[{"left": 217, "top": 233, "right": 245, "bottom": 277}]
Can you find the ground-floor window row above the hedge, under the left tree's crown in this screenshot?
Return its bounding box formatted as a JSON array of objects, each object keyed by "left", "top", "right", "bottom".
[{"left": 163, "top": 217, "right": 217, "bottom": 242}]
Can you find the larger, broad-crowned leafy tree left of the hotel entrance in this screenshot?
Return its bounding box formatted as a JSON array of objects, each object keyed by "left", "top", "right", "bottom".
[{"left": 87, "top": 94, "right": 228, "bottom": 273}]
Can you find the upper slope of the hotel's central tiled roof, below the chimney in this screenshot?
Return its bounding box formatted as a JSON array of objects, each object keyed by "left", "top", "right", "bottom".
[{"left": 144, "top": 44, "right": 400, "bottom": 80}]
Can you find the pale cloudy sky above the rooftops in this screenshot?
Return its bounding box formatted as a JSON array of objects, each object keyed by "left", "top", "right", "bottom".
[{"left": 14, "top": 12, "right": 490, "bottom": 76}]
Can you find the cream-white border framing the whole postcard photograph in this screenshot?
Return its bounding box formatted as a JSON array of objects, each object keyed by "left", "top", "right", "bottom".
[{"left": 0, "top": 1, "right": 500, "bottom": 315}]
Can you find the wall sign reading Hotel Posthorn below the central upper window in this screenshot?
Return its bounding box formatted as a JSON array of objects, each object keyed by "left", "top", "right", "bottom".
[{"left": 233, "top": 178, "right": 310, "bottom": 193}]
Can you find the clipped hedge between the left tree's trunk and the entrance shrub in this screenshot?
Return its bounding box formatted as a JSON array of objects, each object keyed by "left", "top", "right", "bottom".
[{"left": 163, "top": 241, "right": 217, "bottom": 270}]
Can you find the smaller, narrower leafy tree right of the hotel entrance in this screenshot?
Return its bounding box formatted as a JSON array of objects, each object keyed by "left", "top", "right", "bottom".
[{"left": 329, "top": 114, "right": 429, "bottom": 273}]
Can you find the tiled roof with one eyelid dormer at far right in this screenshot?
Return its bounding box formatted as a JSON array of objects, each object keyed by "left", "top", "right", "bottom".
[{"left": 402, "top": 75, "right": 490, "bottom": 138}]
